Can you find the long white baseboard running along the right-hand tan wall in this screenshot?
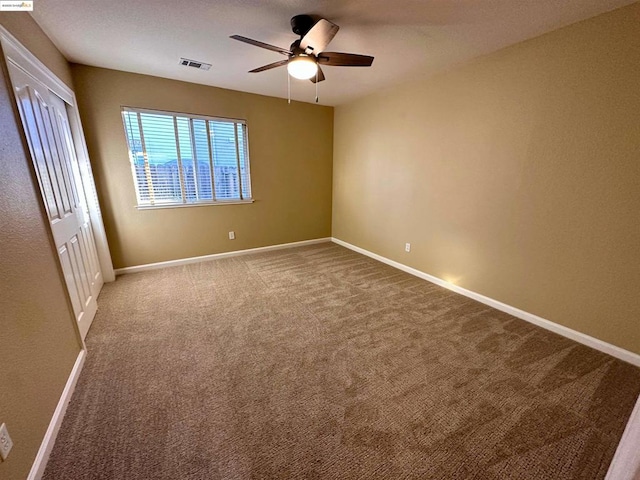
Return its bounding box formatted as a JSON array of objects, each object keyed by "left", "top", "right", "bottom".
[{"left": 331, "top": 237, "right": 640, "bottom": 367}]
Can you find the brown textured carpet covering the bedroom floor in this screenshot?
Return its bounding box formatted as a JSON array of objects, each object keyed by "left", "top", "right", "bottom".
[{"left": 44, "top": 243, "right": 640, "bottom": 480}]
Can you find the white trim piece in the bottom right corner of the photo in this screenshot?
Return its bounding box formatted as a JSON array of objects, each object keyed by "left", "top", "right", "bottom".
[{"left": 604, "top": 396, "right": 640, "bottom": 480}]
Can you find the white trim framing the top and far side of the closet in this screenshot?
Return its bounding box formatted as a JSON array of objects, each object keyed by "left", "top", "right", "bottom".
[{"left": 0, "top": 25, "right": 116, "bottom": 283}]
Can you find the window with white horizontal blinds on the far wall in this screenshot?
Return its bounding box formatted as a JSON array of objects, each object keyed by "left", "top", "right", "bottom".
[{"left": 122, "top": 107, "right": 251, "bottom": 207}]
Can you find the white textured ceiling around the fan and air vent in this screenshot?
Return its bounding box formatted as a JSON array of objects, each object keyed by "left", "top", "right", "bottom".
[{"left": 33, "top": 0, "right": 635, "bottom": 105}]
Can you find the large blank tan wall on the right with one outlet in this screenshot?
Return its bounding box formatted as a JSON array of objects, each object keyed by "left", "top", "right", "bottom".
[{"left": 333, "top": 3, "right": 640, "bottom": 353}]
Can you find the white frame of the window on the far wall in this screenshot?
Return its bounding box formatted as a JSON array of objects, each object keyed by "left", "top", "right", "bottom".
[{"left": 120, "top": 105, "right": 255, "bottom": 210}]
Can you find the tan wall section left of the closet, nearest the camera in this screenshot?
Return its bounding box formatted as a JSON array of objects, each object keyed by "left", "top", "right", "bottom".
[{"left": 0, "top": 14, "right": 80, "bottom": 480}]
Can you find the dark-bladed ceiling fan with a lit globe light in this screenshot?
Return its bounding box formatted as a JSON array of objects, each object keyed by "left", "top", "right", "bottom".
[{"left": 230, "top": 15, "right": 373, "bottom": 83}]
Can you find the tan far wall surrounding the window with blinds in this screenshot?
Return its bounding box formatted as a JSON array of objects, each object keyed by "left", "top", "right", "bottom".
[{"left": 72, "top": 65, "right": 333, "bottom": 268}]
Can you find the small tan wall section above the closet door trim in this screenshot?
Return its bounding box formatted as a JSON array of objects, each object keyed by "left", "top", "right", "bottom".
[{"left": 0, "top": 12, "right": 73, "bottom": 88}]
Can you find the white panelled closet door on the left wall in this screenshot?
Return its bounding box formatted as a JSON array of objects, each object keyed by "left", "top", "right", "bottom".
[{"left": 8, "top": 63, "right": 103, "bottom": 338}]
